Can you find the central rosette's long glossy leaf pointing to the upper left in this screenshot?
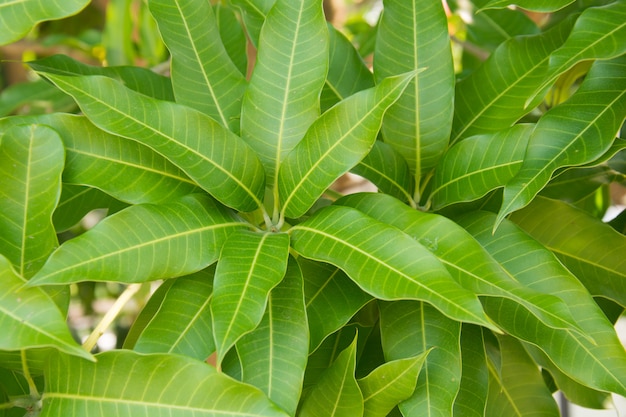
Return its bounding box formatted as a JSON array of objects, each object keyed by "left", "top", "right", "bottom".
[{"left": 34, "top": 74, "right": 264, "bottom": 211}]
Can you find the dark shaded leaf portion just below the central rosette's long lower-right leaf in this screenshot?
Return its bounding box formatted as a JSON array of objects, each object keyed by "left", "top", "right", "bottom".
[{"left": 298, "top": 258, "right": 372, "bottom": 352}]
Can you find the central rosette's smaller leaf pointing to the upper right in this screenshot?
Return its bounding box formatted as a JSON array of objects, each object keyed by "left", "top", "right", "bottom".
[{"left": 278, "top": 72, "right": 415, "bottom": 218}]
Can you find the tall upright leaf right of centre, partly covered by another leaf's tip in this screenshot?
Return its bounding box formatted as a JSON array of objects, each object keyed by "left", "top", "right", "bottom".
[{"left": 374, "top": 0, "right": 455, "bottom": 185}]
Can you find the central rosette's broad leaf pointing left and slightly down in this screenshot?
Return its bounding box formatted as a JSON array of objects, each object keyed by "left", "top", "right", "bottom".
[{"left": 30, "top": 194, "right": 245, "bottom": 285}]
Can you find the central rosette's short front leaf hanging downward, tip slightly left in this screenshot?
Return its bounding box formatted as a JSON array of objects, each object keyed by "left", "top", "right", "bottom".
[{"left": 211, "top": 230, "right": 289, "bottom": 363}]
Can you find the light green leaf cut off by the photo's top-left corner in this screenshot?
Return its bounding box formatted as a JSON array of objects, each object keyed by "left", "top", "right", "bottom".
[{"left": 0, "top": 0, "right": 89, "bottom": 45}]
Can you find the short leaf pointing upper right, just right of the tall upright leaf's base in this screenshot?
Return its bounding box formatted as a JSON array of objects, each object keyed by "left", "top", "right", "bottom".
[{"left": 430, "top": 124, "right": 534, "bottom": 210}]
